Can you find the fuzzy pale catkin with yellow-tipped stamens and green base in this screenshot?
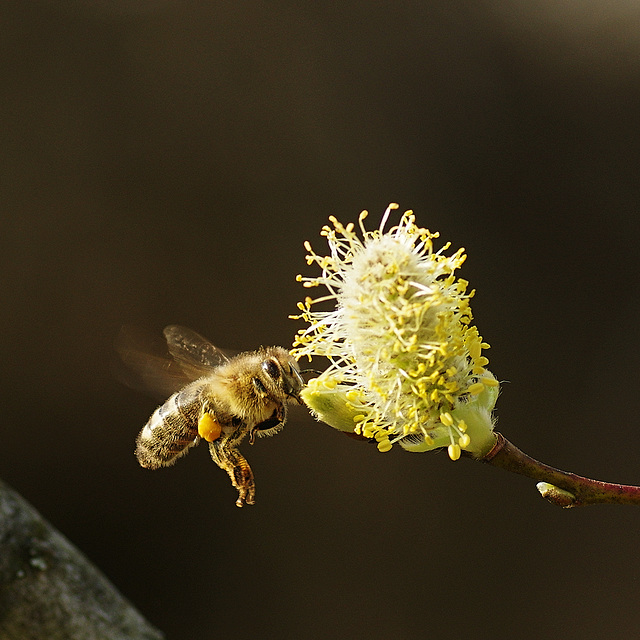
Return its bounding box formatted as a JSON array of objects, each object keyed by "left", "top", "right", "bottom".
[{"left": 292, "top": 205, "right": 498, "bottom": 459}]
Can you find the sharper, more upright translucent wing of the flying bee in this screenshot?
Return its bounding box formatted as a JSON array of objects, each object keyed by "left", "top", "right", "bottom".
[{"left": 163, "top": 324, "right": 229, "bottom": 380}]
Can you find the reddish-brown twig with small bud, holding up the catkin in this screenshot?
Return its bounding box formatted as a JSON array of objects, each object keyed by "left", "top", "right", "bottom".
[{"left": 482, "top": 433, "right": 640, "bottom": 508}]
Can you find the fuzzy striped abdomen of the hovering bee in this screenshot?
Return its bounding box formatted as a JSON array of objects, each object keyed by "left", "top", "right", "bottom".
[{"left": 136, "top": 381, "right": 203, "bottom": 469}]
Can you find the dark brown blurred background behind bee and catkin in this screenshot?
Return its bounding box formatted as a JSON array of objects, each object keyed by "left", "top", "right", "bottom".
[{"left": 0, "top": 0, "right": 640, "bottom": 640}]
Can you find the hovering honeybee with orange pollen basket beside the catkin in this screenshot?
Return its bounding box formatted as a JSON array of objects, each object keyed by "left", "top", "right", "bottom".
[{"left": 119, "top": 325, "right": 304, "bottom": 507}]
